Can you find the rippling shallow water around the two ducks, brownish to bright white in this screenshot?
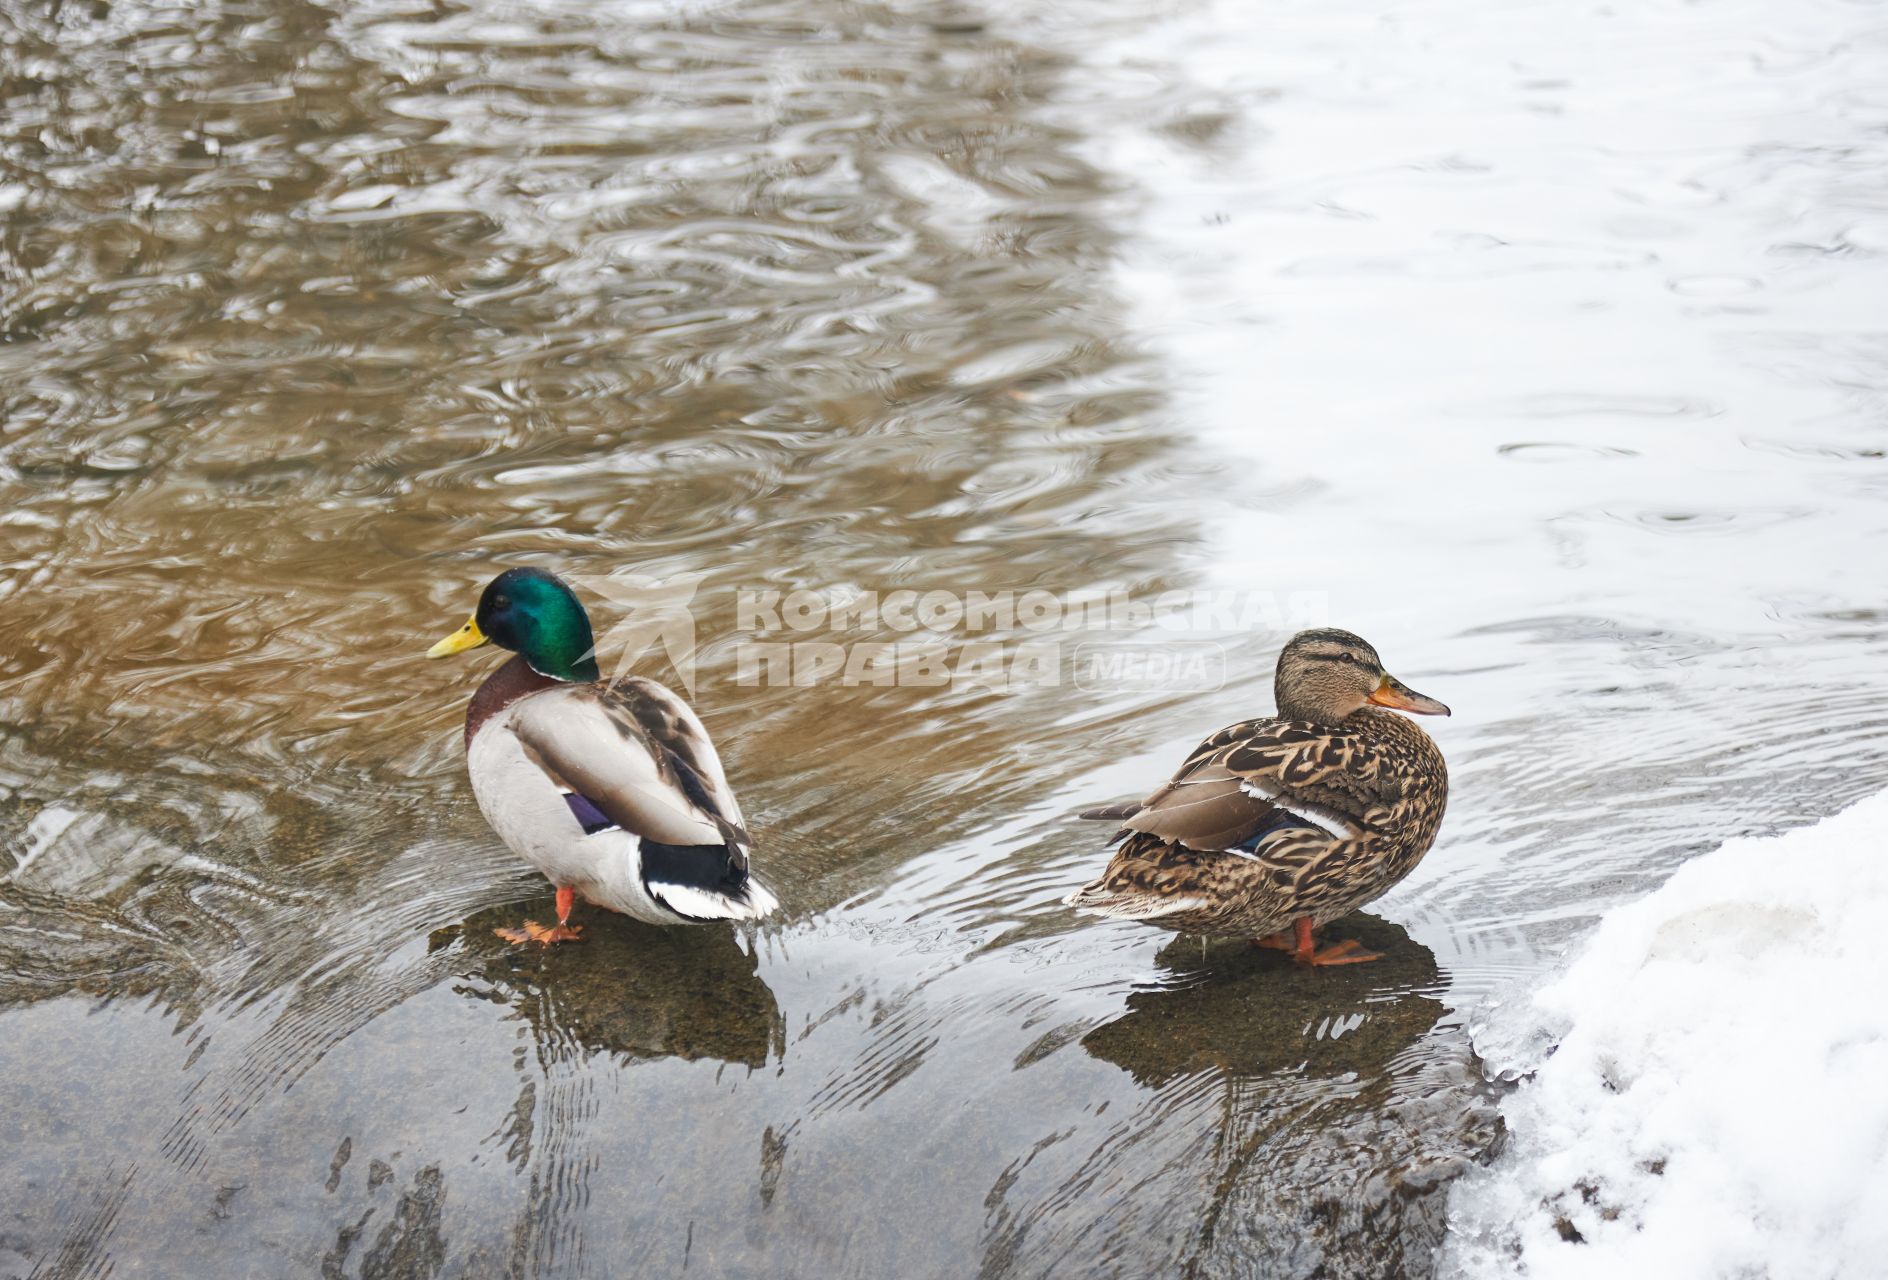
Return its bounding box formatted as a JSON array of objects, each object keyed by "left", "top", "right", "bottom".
[{"left": 0, "top": 0, "right": 1888, "bottom": 1276}]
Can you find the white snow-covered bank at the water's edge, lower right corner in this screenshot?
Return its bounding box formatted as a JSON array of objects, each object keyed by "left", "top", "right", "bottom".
[{"left": 1444, "top": 793, "right": 1888, "bottom": 1280}]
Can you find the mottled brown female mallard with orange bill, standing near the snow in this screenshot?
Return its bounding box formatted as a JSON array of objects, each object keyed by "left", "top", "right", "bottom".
[{"left": 1069, "top": 631, "right": 1448, "bottom": 965}]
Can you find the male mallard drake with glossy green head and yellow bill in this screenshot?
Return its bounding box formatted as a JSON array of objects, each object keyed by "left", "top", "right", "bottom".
[{"left": 427, "top": 568, "right": 778, "bottom": 946}]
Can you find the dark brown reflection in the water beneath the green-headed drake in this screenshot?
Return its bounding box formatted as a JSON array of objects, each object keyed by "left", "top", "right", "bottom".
[{"left": 449, "top": 908, "right": 785, "bottom": 1067}]
